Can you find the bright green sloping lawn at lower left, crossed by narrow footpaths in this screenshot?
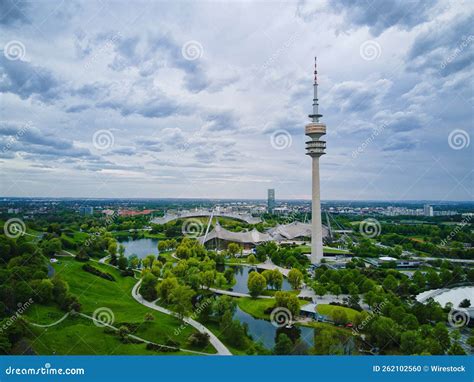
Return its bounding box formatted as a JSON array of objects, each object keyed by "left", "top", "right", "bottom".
[{"left": 27, "top": 258, "right": 215, "bottom": 354}]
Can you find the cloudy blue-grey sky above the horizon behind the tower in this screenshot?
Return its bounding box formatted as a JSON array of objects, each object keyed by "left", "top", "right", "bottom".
[{"left": 0, "top": 0, "right": 474, "bottom": 200}]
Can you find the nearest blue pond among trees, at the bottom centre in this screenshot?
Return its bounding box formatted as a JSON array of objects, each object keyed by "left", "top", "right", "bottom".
[{"left": 234, "top": 307, "right": 314, "bottom": 349}]
